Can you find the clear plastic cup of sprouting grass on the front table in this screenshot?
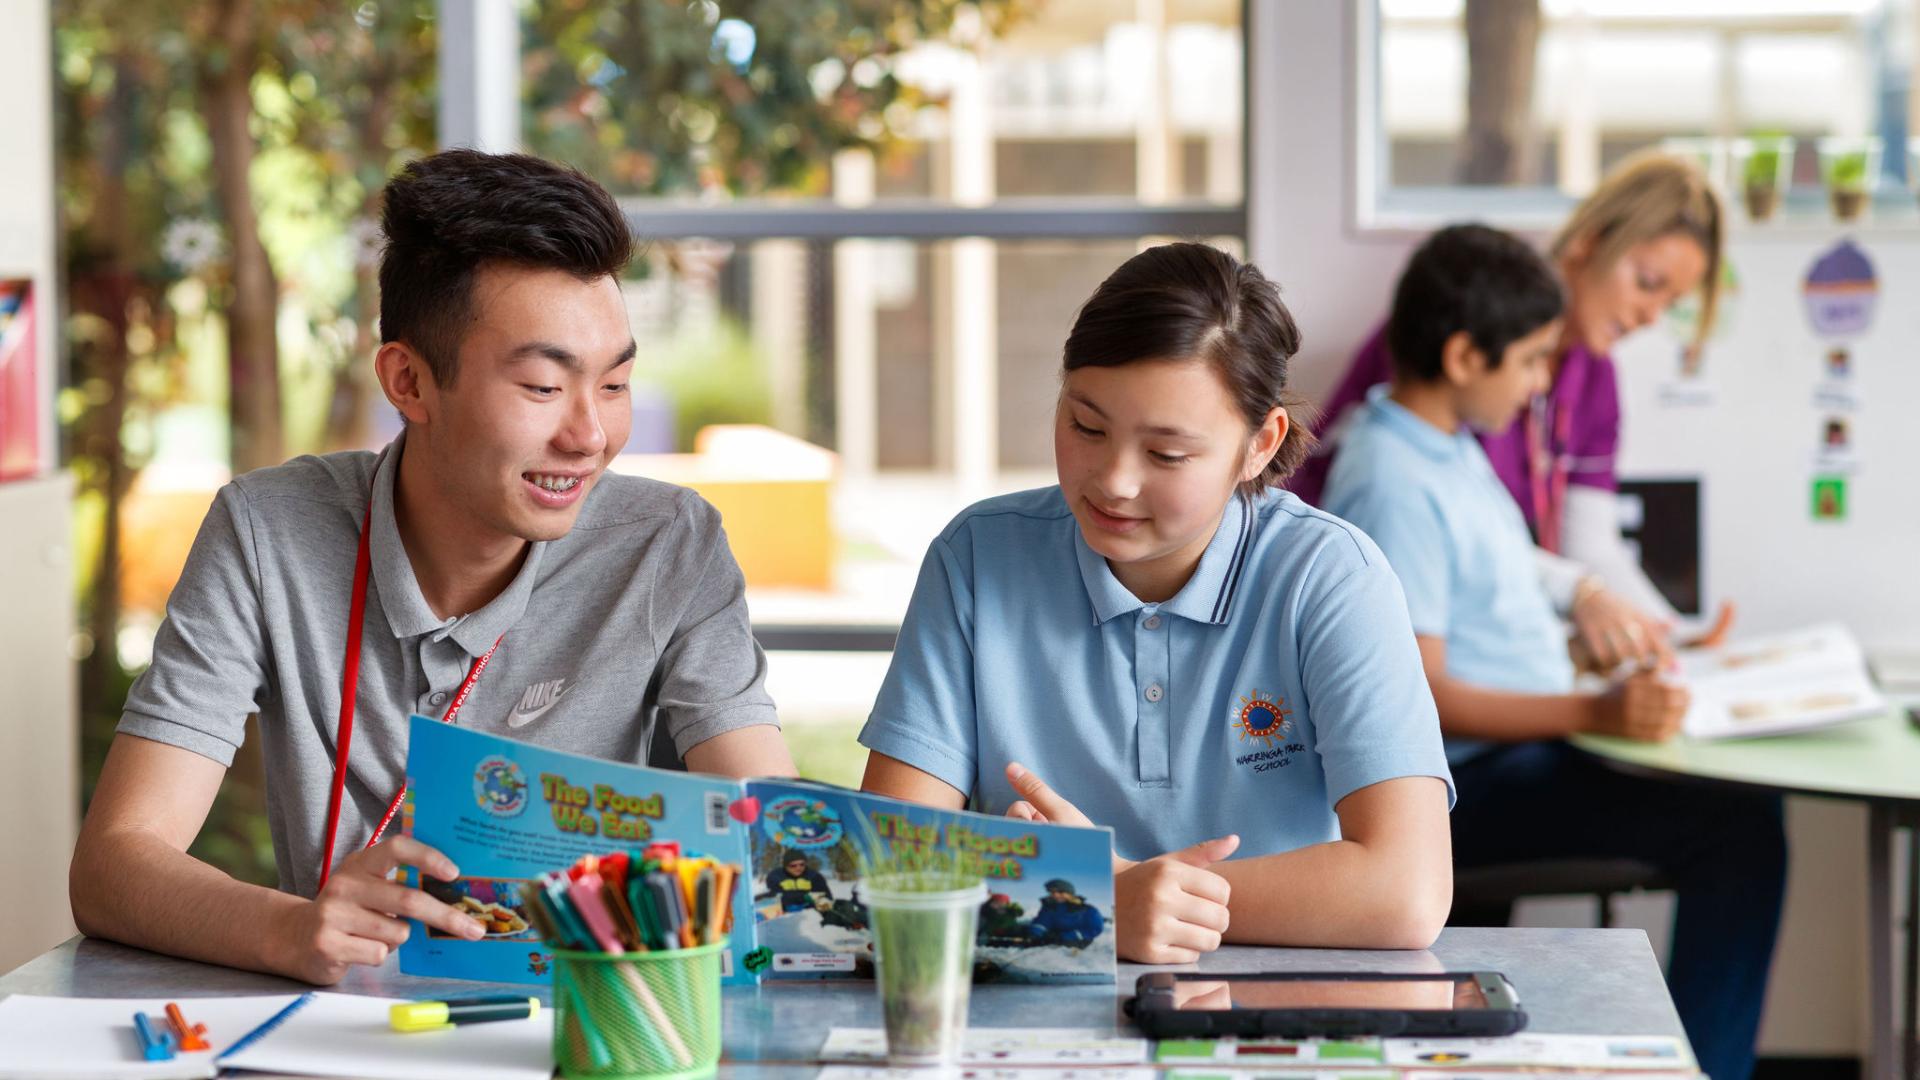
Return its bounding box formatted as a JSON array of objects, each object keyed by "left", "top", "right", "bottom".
[{"left": 860, "top": 876, "right": 987, "bottom": 1067}]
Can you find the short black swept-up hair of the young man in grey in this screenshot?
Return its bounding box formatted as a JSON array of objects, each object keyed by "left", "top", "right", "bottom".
[{"left": 380, "top": 148, "right": 634, "bottom": 386}]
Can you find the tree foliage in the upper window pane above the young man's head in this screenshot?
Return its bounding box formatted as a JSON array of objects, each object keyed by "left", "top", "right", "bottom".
[{"left": 522, "top": 0, "right": 1031, "bottom": 194}]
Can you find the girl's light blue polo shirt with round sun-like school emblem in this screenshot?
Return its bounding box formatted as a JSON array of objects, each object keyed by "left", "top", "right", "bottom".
[{"left": 860, "top": 488, "right": 1453, "bottom": 859}]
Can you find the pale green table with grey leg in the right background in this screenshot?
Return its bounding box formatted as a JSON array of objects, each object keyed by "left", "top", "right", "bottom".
[{"left": 1572, "top": 709, "right": 1920, "bottom": 1080}]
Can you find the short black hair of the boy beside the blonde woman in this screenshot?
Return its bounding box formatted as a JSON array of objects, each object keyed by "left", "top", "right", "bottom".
[{"left": 1386, "top": 225, "right": 1565, "bottom": 382}]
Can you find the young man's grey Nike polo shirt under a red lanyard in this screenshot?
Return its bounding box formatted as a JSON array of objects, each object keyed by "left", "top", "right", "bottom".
[{"left": 119, "top": 428, "right": 778, "bottom": 896}]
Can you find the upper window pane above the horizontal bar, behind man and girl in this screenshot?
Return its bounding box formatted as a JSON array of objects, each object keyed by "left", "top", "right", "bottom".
[{"left": 520, "top": 0, "right": 1242, "bottom": 204}]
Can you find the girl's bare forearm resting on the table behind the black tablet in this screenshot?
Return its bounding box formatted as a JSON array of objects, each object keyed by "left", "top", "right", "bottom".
[{"left": 1210, "top": 840, "right": 1453, "bottom": 949}]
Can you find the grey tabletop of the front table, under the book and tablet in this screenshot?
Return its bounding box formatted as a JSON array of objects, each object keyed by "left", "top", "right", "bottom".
[{"left": 0, "top": 928, "right": 1684, "bottom": 1076}]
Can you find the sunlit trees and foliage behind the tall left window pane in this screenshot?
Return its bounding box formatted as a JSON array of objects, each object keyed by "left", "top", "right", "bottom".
[{"left": 54, "top": 0, "right": 434, "bottom": 884}]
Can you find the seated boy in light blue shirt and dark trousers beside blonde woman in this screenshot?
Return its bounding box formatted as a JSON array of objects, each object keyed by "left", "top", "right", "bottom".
[{"left": 1323, "top": 225, "right": 1786, "bottom": 1080}]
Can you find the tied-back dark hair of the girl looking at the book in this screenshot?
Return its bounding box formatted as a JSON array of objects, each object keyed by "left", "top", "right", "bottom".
[{"left": 1064, "top": 244, "right": 1313, "bottom": 494}]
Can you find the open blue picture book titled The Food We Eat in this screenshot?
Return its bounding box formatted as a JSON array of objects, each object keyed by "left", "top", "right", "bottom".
[{"left": 399, "top": 717, "right": 1116, "bottom": 984}]
